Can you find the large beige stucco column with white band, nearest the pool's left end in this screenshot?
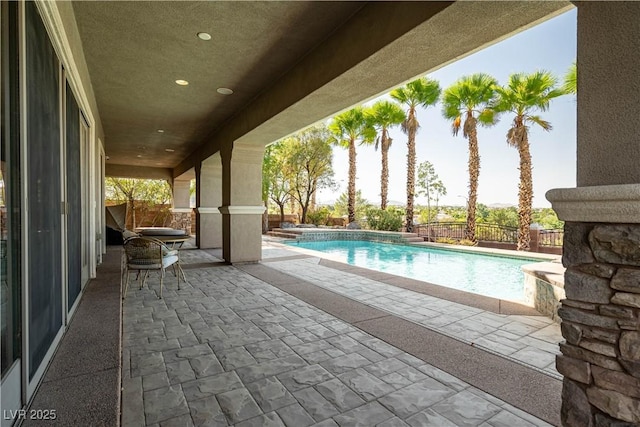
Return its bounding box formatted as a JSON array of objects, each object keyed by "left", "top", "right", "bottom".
[{"left": 220, "top": 142, "right": 265, "bottom": 263}]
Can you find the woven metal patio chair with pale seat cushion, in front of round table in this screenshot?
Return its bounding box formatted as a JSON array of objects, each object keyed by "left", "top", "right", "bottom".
[{"left": 122, "top": 236, "right": 180, "bottom": 299}]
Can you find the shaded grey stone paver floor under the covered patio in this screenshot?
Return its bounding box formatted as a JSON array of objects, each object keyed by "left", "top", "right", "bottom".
[{"left": 122, "top": 251, "right": 548, "bottom": 427}]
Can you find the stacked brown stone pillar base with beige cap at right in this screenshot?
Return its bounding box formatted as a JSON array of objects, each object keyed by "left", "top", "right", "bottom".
[{"left": 547, "top": 184, "right": 640, "bottom": 427}]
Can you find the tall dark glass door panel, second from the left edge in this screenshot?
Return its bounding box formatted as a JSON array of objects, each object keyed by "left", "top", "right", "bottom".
[{"left": 24, "top": 2, "right": 64, "bottom": 383}]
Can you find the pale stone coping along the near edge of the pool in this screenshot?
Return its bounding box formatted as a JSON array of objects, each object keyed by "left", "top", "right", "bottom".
[{"left": 261, "top": 239, "right": 549, "bottom": 316}]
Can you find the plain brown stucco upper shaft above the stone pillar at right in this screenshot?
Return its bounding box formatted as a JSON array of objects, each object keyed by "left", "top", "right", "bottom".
[{"left": 576, "top": 1, "right": 640, "bottom": 187}]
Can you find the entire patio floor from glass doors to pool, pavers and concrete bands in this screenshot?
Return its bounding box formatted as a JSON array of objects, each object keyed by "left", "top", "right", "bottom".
[{"left": 27, "top": 239, "right": 562, "bottom": 427}]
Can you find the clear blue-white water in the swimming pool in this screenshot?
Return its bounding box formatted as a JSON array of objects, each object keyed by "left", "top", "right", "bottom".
[{"left": 290, "top": 240, "right": 539, "bottom": 301}]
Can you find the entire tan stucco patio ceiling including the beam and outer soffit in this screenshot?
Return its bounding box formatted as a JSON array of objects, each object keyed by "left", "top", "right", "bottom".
[{"left": 73, "top": 1, "right": 571, "bottom": 176}]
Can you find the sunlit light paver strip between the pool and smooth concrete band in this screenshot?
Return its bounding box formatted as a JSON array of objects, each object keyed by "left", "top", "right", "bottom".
[{"left": 263, "top": 243, "right": 563, "bottom": 379}]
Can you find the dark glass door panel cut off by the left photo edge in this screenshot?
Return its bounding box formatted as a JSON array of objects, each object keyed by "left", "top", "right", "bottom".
[{"left": 0, "top": 2, "right": 22, "bottom": 427}]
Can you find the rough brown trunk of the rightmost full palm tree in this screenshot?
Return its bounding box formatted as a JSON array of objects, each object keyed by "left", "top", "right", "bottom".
[{"left": 518, "top": 130, "right": 533, "bottom": 251}]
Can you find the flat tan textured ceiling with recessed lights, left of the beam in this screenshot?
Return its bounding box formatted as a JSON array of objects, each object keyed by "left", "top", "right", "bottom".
[{"left": 73, "top": 1, "right": 366, "bottom": 168}]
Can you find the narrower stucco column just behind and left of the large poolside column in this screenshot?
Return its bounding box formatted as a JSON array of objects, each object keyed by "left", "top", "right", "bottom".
[{"left": 196, "top": 153, "right": 222, "bottom": 249}]
